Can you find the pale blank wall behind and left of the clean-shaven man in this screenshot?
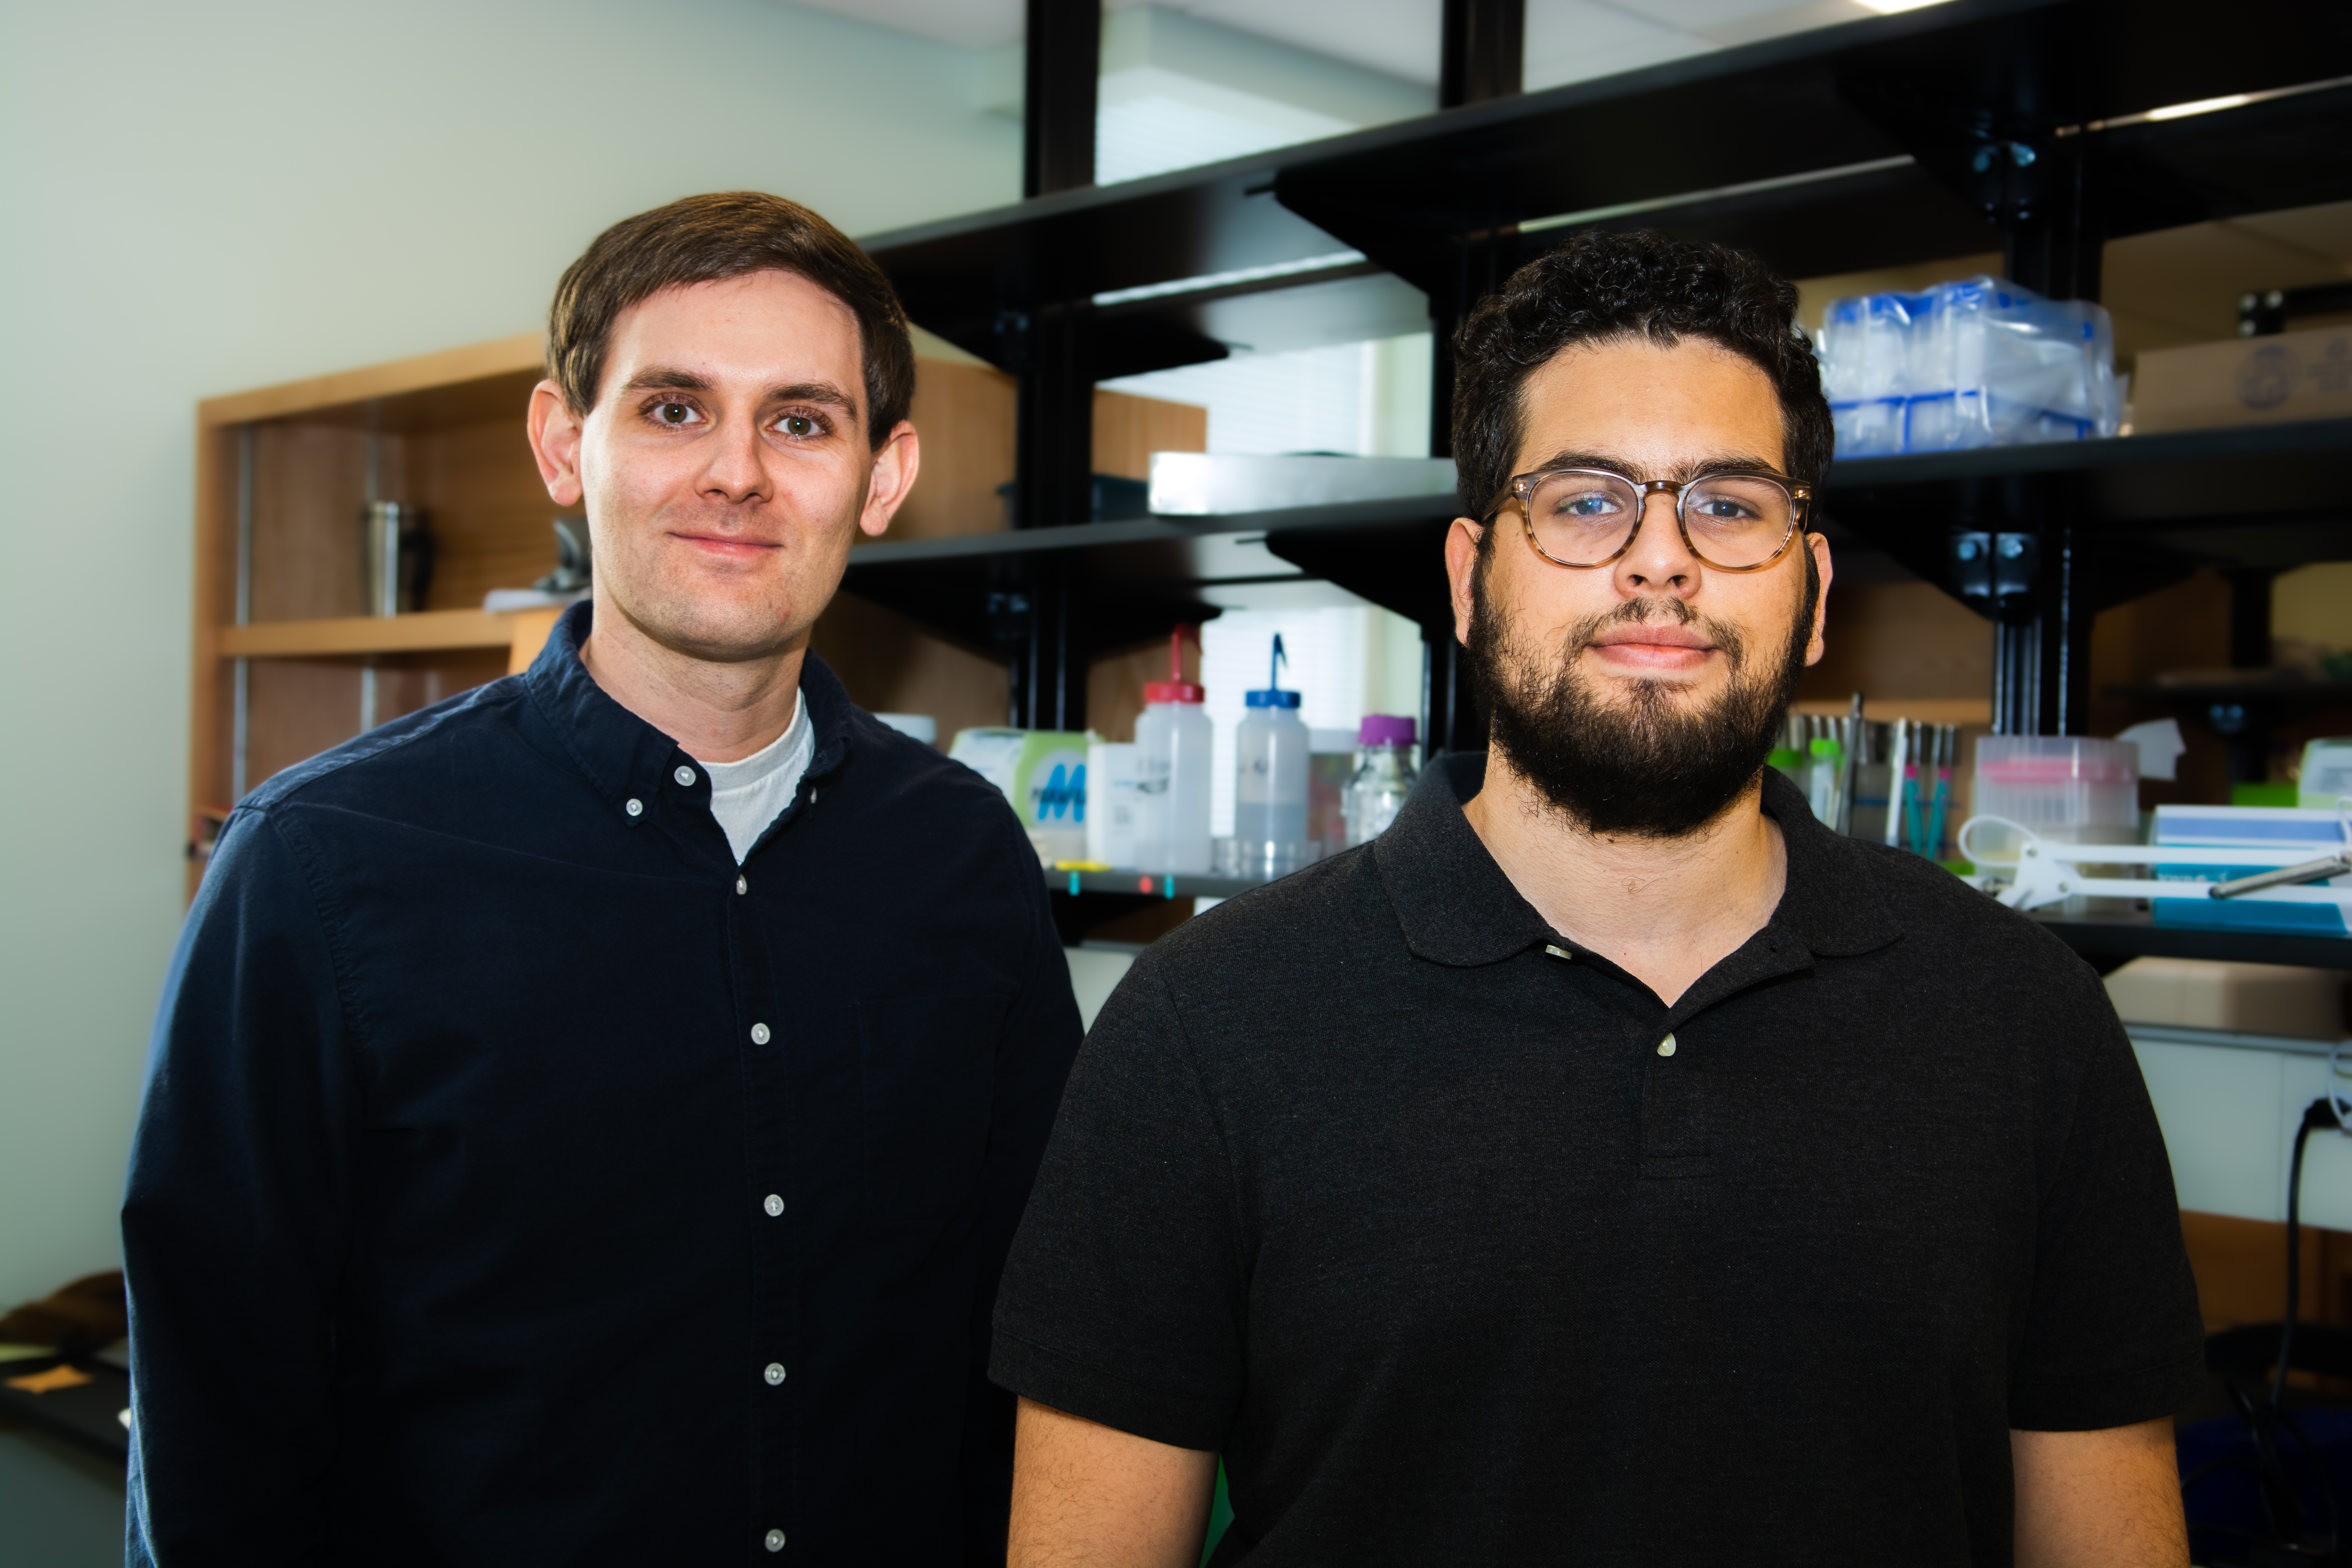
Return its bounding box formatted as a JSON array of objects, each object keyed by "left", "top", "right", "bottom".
[{"left": 0, "top": 0, "right": 1021, "bottom": 1307}]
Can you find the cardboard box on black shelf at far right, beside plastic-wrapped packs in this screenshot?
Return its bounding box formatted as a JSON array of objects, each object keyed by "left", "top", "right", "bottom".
[{"left": 2131, "top": 327, "right": 2352, "bottom": 435}]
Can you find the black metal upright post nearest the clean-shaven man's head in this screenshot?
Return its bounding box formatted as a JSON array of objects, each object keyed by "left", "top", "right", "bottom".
[{"left": 1002, "top": 0, "right": 1103, "bottom": 729}]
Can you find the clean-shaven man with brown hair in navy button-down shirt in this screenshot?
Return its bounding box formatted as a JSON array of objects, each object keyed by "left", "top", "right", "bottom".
[{"left": 122, "top": 193, "right": 1080, "bottom": 1568}]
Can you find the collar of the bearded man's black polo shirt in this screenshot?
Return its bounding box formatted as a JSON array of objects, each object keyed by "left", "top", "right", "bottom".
[{"left": 1371, "top": 752, "right": 1903, "bottom": 968}]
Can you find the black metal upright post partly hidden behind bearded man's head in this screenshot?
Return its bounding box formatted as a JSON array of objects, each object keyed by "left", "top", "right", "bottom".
[{"left": 1421, "top": 0, "right": 1526, "bottom": 752}]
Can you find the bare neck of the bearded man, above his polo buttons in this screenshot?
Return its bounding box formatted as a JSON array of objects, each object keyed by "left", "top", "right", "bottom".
[{"left": 1463, "top": 750, "right": 1788, "bottom": 1006}]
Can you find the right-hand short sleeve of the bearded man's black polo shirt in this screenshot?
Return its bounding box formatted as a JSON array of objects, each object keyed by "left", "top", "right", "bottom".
[{"left": 2009, "top": 976, "right": 2204, "bottom": 1432}]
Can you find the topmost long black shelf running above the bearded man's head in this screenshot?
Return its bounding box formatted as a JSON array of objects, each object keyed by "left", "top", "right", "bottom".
[{"left": 866, "top": 0, "right": 2352, "bottom": 376}]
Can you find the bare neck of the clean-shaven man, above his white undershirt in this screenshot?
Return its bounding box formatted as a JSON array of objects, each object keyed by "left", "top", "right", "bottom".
[{"left": 581, "top": 592, "right": 809, "bottom": 762}]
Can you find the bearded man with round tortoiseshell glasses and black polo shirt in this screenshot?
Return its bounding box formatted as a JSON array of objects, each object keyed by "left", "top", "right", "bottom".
[{"left": 990, "top": 235, "right": 2201, "bottom": 1568}]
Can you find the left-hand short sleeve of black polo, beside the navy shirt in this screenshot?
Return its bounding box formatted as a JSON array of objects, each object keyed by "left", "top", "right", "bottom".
[{"left": 988, "top": 959, "right": 1244, "bottom": 1450}]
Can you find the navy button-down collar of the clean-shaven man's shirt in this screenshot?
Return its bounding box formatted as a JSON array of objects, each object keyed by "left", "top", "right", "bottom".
[{"left": 522, "top": 599, "right": 856, "bottom": 823}]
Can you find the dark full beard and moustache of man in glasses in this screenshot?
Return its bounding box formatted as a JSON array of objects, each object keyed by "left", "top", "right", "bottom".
[{"left": 1465, "top": 555, "right": 1820, "bottom": 839}]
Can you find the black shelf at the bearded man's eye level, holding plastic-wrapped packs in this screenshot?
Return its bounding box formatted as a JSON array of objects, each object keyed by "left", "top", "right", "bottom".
[{"left": 844, "top": 418, "right": 2352, "bottom": 646}]
